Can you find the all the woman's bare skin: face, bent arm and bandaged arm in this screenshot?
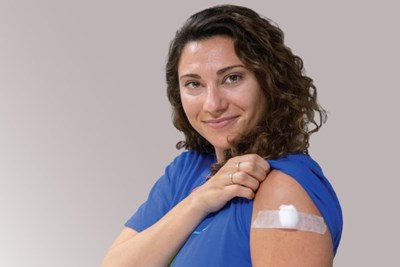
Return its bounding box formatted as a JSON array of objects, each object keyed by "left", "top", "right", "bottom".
[{"left": 102, "top": 36, "right": 333, "bottom": 267}]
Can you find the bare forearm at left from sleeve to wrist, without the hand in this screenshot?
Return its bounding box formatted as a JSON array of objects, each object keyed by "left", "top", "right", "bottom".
[{"left": 102, "top": 196, "right": 207, "bottom": 267}]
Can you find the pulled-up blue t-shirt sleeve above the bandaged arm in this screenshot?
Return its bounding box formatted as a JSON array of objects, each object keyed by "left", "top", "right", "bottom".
[{"left": 268, "top": 155, "right": 343, "bottom": 253}]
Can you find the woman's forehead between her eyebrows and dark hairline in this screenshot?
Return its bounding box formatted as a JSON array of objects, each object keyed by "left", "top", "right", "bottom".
[{"left": 178, "top": 36, "right": 243, "bottom": 74}]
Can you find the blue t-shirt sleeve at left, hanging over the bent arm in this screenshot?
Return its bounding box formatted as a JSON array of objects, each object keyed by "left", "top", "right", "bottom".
[{"left": 125, "top": 159, "right": 180, "bottom": 232}]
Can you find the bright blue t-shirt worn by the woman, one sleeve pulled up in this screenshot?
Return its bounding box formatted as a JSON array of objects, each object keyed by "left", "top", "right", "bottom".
[{"left": 125, "top": 151, "right": 343, "bottom": 267}]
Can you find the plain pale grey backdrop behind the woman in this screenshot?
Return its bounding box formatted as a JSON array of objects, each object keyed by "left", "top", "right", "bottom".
[{"left": 0, "top": 0, "right": 400, "bottom": 267}]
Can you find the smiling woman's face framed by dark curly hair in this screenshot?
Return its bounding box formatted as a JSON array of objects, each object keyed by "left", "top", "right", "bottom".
[{"left": 178, "top": 36, "right": 266, "bottom": 160}]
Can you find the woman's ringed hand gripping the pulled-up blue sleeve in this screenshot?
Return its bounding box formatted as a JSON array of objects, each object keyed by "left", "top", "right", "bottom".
[{"left": 190, "top": 154, "right": 270, "bottom": 213}]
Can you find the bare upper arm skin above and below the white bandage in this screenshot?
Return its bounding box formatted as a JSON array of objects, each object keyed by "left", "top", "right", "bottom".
[{"left": 250, "top": 170, "right": 333, "bottom": 267}]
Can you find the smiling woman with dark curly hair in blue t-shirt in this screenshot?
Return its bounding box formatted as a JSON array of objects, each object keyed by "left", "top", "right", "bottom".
[{"left": 103, "top": 5, "right": 342, "bottom": 267}]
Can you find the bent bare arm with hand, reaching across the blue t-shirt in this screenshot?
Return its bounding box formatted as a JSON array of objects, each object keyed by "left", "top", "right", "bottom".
[{"left": 103, "top": 155, "right": 269, "bottom": 267}]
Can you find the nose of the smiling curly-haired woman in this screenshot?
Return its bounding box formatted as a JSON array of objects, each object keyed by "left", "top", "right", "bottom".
[{"left": 203, "top": 85, "right": 228, "bottom": 116}]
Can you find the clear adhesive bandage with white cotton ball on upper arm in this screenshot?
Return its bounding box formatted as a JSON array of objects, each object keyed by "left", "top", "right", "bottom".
[{"left": 251, "top": 205, "right": 326, "bottom": 234}]
